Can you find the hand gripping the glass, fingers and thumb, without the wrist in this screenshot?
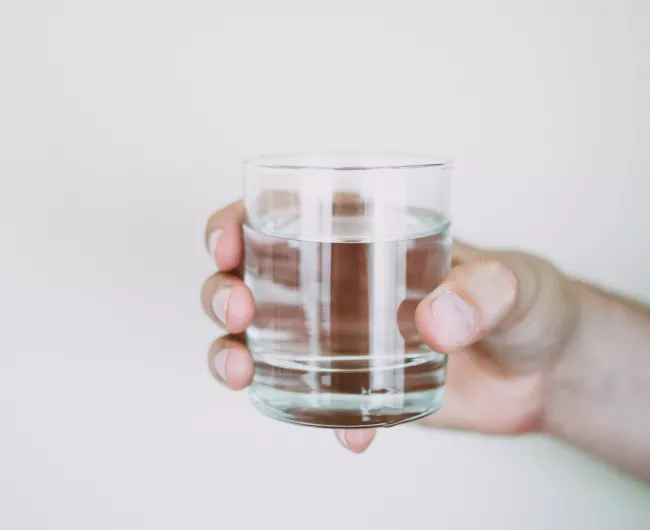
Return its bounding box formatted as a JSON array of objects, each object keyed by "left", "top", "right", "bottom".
[{"left": 201, "top": 198, "right": 578, "bottom": 453}]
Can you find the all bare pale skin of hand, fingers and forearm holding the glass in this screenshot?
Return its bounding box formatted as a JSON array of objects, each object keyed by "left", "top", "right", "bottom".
[{"left": 201, "top": 202, "right": 650, "bottom": 482}]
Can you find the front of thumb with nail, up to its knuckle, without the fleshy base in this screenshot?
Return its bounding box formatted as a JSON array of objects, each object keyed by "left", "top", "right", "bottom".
[{"left": 415, "top": 260, "right": 517, "bottom": 353}]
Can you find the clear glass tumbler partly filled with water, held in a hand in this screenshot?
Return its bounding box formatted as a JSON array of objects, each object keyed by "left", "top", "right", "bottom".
[{"left": 244, "top": 155, "right": 451, "bottom": 429}]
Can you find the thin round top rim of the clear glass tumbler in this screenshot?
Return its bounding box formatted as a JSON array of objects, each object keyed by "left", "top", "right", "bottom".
[{"left": 243, "top": 152, "right": 452, "bottom": 172}]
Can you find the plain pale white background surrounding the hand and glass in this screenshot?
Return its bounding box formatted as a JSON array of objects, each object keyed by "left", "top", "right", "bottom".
[{"left": 0, "top": 0, "right": 650, "bottom": 530}]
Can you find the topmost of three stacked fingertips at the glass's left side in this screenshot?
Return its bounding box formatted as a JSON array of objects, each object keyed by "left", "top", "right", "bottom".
[{"left": 205, "top": 201, "right": 244, "bottom": 271}]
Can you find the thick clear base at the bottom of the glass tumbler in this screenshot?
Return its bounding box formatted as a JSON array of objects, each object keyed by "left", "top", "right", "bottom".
[{"left": 250, "top": 383, "right": 445, "bottom": 429}]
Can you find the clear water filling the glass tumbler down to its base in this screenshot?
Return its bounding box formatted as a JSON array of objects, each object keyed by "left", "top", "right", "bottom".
[{"left": 245, "top": 210, "right": 451, "bottom": 428}]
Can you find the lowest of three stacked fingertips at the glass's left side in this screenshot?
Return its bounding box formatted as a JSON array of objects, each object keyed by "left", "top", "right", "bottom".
[{"left": 208, "top": 335, "right": 255, "bottom": 390}]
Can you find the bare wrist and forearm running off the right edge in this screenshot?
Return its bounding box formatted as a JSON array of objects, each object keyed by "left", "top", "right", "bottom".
[{"left": 542, "top": 283, "right": 650, "bottom": 480}]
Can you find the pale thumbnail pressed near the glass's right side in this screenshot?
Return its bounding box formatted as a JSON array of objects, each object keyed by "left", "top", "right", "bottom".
[{"left": 431, "top": 291, "right": 476, "bottom": 348}]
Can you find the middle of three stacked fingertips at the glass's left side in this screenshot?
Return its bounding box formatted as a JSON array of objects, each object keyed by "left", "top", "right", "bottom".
[{"left": 201, "top": 273, "right": 255, "bottom": 333}]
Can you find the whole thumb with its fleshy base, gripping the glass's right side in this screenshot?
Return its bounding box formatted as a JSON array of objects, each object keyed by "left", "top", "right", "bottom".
[{"left": 415, "top": 245, "right": 579, "bottom": 371}]
